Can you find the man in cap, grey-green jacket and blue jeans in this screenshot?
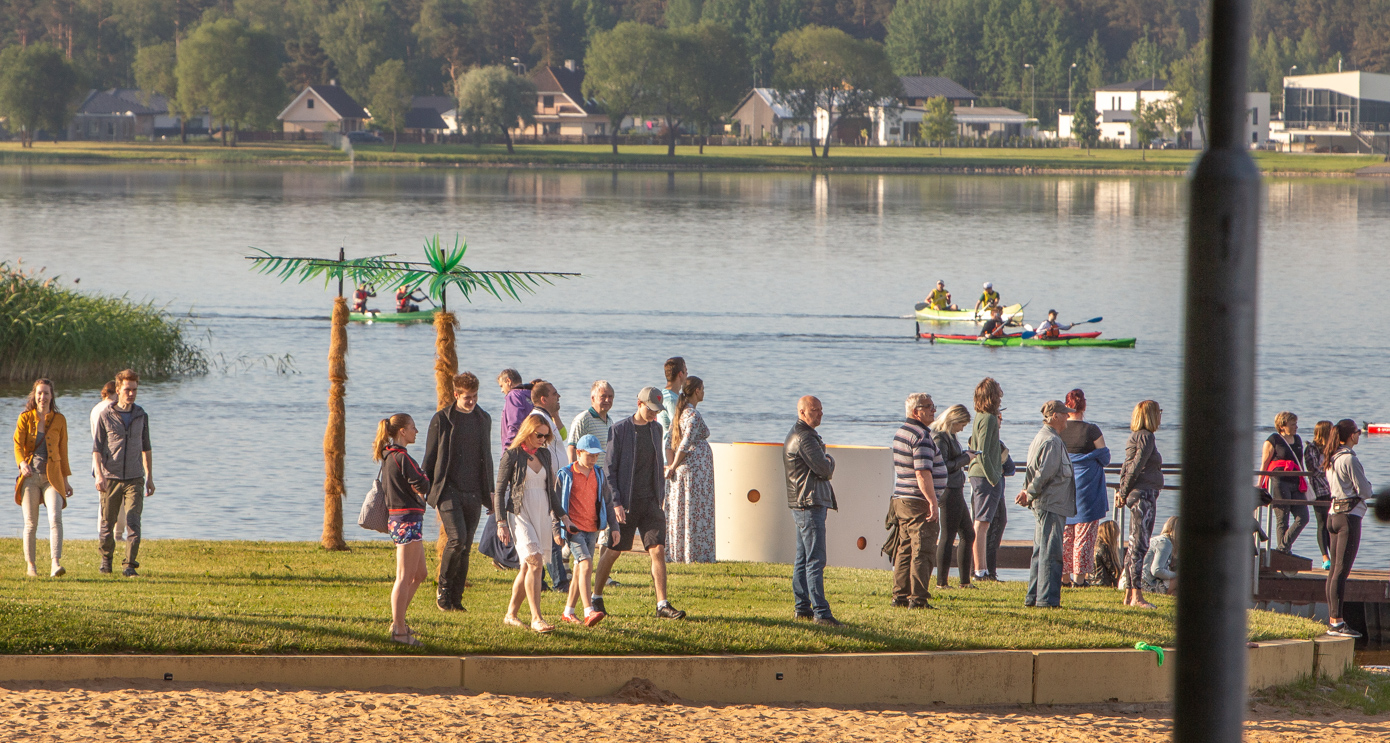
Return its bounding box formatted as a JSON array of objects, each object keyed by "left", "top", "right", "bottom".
[{"left": 1015, "top": 400, "right": 1076, "bottom": 608}]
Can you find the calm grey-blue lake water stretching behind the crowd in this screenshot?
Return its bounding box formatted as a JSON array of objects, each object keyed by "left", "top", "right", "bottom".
[{"left": 0, "top": 167, "right": 1390, "bottom": 568}]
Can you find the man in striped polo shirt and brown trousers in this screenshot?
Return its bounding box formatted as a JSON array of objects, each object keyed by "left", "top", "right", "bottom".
[{"left": 892, "top": 392, "right": 947, "bottom": 608}]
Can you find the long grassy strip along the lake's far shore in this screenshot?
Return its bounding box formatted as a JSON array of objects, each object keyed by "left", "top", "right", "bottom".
[{"left": 0, "top": 142, "right": 1383, "bottom": 175}]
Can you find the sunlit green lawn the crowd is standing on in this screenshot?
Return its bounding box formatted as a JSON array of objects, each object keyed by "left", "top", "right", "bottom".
[{"left": 0, "top": 539, "right": 1323, "bottom": 656}]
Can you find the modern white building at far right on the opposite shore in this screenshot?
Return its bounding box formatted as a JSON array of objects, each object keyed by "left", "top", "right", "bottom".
[{"left": 1277, "top": 71, "right": 1390, "bottom": 153}]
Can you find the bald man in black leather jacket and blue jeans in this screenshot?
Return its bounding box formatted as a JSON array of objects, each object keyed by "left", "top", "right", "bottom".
[{"left": 783, "top": 394, "right": 842, "bottom": 626}]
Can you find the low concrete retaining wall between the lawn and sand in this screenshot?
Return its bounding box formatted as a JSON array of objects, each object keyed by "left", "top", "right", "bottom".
[{"left": 0, "top": 637, "right": 1354, "bottom": 706}]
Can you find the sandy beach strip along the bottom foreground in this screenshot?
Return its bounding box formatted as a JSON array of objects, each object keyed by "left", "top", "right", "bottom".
[{"left": 0, "top": 682, "right": 1390, "bottom": 743}]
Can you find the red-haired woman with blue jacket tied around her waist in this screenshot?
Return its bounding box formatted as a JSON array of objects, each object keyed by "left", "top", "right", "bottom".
[{"left": 1062, "top": 389, "right": 1111, "bottom": 587}]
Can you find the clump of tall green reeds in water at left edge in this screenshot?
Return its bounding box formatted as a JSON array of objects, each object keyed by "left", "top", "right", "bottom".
[{"left": 0, "top": 262, "right": 207, "bottom": 382}]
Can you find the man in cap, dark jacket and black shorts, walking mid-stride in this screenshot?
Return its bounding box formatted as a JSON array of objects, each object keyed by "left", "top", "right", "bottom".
[{"left": 591, "top": 387, "right": 685, "bottom": 619}]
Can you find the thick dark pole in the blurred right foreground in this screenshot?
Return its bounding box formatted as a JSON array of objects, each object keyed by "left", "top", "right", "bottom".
[{"left": 1173, "top": 0, "right": 1259, "bottom": 743}]
